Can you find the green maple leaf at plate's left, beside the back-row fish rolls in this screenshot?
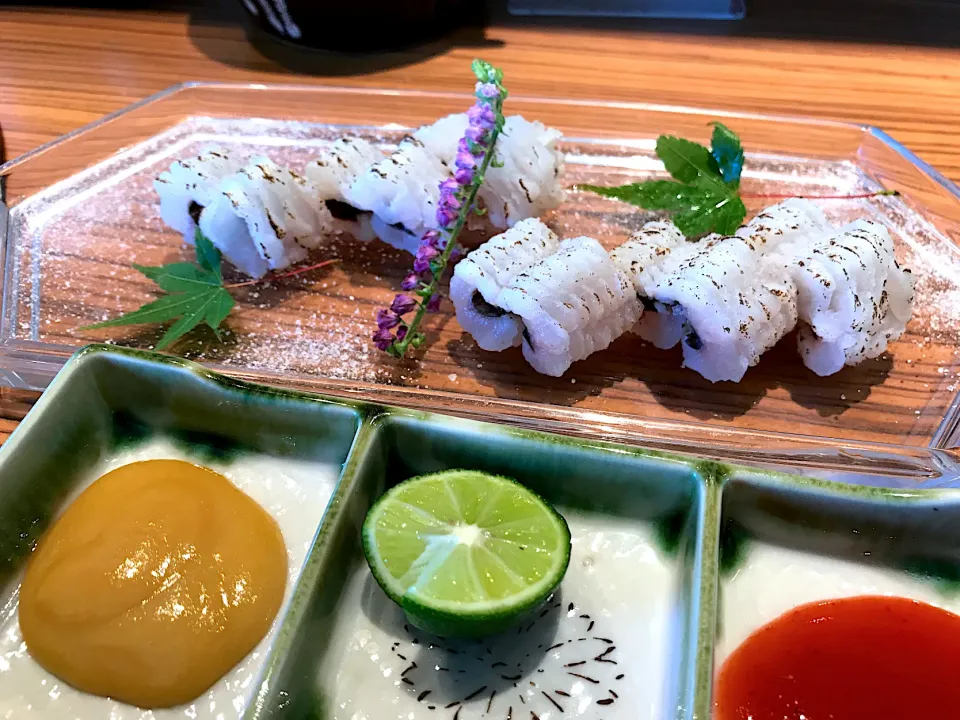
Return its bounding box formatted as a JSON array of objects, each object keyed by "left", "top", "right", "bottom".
[{"left": 80, "top": 230, "right": 236, "bottom": 350}]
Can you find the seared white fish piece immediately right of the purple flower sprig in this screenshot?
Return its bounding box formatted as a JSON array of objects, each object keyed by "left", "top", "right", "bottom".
[{"left": 477, "top": 115, "right": 566, "bottom": 228}]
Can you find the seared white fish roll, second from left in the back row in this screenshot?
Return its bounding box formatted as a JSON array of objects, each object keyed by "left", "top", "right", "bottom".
[{"left": 200, "top": 158, "right": 333, "bottom": 278}]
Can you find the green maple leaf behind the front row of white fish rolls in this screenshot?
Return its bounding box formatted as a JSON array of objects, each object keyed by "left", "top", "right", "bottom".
[{"left": 578, "top": 123, "right": 747, "bottom": 237}]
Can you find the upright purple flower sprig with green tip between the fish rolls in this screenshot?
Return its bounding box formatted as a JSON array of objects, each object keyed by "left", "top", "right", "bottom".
[{"left": 373, "top": 60, "right": 507, "bottom": 358}]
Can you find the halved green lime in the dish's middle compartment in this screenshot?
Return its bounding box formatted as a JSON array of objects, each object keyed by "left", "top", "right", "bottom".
[{"left": 363, "top": 470, "right": 570, "bottom": 637}]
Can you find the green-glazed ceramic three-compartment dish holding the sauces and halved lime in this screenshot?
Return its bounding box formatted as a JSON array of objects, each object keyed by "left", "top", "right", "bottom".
[{"left": 0, "top": 346, "right": 960, "bottom": 720}]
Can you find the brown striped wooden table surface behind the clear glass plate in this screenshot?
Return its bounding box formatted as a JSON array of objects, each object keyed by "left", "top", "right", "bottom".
[{"left": 0, "top": 0, "right": 960, "bottom": 438}]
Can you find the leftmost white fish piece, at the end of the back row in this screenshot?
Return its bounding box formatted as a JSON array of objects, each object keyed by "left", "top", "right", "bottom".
[{"left": 153, "top": 148, "right": 243, "bottom": 245}]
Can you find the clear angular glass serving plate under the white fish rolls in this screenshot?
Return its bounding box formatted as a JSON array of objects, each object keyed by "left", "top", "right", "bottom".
[{"left": 0, "top": 84, "right": 960, "bottom": 483}]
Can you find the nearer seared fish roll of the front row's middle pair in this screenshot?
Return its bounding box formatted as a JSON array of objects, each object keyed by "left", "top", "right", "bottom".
[{"left": 649, "top": 236, "right": 797, "bottom": 382}]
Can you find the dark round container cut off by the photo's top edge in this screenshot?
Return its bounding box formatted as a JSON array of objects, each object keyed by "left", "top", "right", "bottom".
[{"left": 241, "top": 0, "right": 468, "bottom": 52}]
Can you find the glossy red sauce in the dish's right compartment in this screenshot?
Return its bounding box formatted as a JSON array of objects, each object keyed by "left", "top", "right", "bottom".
[{"left": 714, "top": 596, "right": 960, "bottom": 720}]
